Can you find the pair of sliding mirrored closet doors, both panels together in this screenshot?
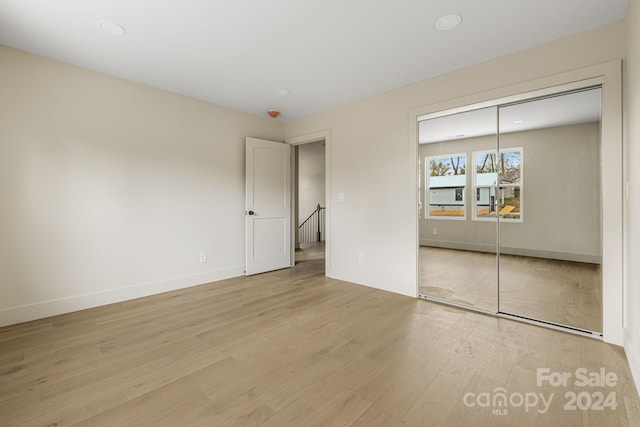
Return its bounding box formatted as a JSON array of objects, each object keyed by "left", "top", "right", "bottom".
[{"left": 418, "top": 87, "right": 602, "bottom": 333}]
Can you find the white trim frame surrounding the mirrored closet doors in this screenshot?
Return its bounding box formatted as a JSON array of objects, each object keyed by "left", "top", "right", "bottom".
[{"left": 409, "top": 60, "right": 624, "bottom": 346}]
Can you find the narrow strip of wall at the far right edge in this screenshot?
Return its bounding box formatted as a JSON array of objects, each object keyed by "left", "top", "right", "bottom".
[{"left": 624, "top": 0, "right": 640, "bottom": 390}]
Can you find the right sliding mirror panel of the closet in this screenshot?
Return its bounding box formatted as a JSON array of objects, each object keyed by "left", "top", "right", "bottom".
[{"left": 497, "top": 88, "right": 602, "bottom": 332}]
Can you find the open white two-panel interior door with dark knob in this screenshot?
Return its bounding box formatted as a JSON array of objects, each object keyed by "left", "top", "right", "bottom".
[{"left": 245, "top": 138, "right": 291, "bottom": 275}]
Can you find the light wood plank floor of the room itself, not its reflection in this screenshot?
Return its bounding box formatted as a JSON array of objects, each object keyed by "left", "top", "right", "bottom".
[{"left": 0, "top": 246, "right": 640, "bottom": 427}]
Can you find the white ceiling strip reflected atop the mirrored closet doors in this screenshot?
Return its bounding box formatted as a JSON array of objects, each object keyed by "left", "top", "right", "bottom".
[{"left": 418, "top": 88, "right": 602, "bottom": 144}]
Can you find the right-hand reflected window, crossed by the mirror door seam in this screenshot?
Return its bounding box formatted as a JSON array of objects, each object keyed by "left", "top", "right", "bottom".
[{"left": 473, "top": 147, "right": 523, "bottom": 222}]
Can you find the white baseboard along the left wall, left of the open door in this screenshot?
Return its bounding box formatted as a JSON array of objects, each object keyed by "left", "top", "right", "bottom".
[{"left": 0, "top": 266, "right": 244, "bottom": 326}]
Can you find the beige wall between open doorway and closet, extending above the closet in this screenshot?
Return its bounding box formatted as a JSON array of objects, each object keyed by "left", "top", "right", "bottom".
[{"left": 285, "top": 22, "right": 625, "bottom": 295}]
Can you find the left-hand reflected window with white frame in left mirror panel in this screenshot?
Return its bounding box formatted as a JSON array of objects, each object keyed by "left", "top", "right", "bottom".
[{"left": 424, "top": 153, "right": 467, "bottom": 219}]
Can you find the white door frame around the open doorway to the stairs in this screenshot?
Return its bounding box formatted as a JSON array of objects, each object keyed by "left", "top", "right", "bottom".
[{"left": 284, "top": 129, "right": 331, "bottom": 276}]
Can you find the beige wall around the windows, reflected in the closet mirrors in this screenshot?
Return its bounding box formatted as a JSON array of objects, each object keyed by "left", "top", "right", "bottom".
[{"left": 419, "top": 123, "right": 601, "bottom": 263}]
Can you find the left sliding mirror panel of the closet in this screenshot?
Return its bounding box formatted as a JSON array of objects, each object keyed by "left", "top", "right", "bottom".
[{"left": 418, "top": 107, "right": 498, "bottom": 312}]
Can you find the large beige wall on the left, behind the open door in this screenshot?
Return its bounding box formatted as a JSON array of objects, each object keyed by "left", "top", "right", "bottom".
[{"left": 0, "top": 47, "right": 283, "bottom": 325}]
